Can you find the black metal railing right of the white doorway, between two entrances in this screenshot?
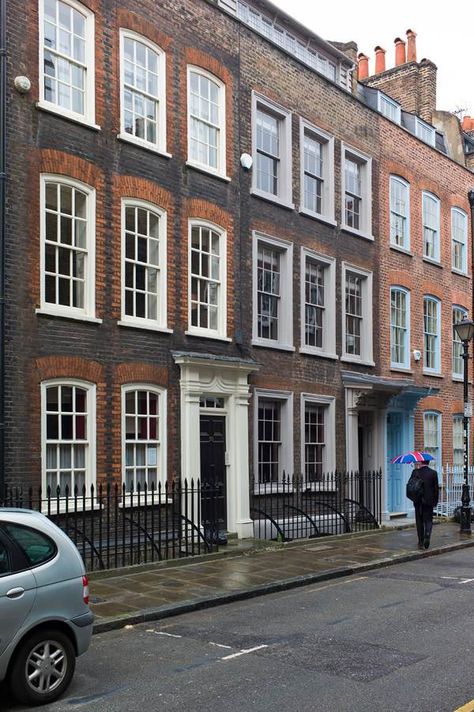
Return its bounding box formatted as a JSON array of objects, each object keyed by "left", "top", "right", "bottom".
[{"left": 250, "top": 471, "right": 382, "bottom": 541}]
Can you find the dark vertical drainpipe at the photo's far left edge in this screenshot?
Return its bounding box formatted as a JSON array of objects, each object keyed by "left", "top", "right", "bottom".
[{"left": 0, "top": 0, "right": 7, "bottom": 499}]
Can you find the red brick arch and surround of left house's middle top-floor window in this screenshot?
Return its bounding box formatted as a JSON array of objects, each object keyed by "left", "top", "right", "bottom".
[{"left": 109, "top": 7, "right": 174, "bottom": 136}]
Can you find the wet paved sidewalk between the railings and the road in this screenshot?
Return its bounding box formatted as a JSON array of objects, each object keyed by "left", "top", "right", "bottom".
[{"left": 89, "top": 522, "right": 474, "bottom": 633}]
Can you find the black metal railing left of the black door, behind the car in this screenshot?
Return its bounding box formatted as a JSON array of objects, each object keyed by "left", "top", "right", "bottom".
[{"left": 0, "top": 480, "right": 223, "bottom": 571}]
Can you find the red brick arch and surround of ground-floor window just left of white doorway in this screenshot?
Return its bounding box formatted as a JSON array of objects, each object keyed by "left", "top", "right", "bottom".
[{"left": 110, "top": 362, "right": 169, "bottom": 484}]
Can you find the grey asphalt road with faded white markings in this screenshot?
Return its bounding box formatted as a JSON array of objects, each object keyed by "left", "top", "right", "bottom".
[{"left": 0, "top": 549, "right": 474, "bottom": 712}]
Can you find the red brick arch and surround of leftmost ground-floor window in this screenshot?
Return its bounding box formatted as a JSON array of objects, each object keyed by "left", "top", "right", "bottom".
[{"left": 29, "top": 356, "right": 106, "bottom": 487}]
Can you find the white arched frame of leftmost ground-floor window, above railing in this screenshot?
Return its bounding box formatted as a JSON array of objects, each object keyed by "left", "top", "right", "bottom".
[{"left": 41, "top": 378, "right": 97, "bottom": 500}]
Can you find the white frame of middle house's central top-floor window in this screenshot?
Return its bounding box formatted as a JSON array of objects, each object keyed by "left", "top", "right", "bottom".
[{"left": 300, "top": 119, "right": 336, "bottom": 225}]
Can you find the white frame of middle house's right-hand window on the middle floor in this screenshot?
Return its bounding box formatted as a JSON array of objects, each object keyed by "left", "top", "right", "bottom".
[{"left": 341, "top": 262, "right": 375, "bottom": 366}]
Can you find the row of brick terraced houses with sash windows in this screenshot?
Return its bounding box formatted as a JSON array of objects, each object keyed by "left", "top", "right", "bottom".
[{"left": 4, "top": 0, "right": 472, "bottom": 536}]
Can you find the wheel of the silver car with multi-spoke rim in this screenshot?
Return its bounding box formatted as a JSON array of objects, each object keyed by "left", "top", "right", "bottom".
[{"left": 10, "top": 628, "right": 76, "bottom": 705}]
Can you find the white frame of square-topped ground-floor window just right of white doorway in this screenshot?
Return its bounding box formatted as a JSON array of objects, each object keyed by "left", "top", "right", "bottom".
[{"left": 254, "top": 388, "right": 294, "bottom": 493}]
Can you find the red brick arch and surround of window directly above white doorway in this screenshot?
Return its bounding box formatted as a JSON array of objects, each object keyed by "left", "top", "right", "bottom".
[{"left": 181, "top": 199, "right": 235, "bottom": 336}]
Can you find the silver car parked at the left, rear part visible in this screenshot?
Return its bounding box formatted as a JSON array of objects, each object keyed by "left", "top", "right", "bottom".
[{"left": 0, "top": 508, "right": 94, "bottom": 705}]
